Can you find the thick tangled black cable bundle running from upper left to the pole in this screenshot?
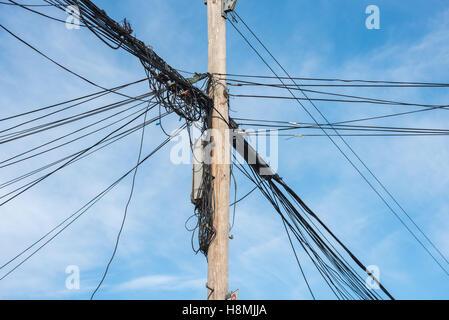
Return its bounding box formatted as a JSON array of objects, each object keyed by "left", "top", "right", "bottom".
[{"left": 43, "top": 0, "right": 212, "bottom": 122}]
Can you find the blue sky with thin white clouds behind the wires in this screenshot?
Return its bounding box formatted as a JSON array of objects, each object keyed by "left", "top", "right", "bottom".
[{"left": 0, "top": 0, "right": 449, "bottom": 299}]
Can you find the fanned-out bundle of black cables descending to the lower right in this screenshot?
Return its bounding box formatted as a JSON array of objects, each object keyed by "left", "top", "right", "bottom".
[{"left": 236, "top": 160, "right": 394, "bottom": 300}]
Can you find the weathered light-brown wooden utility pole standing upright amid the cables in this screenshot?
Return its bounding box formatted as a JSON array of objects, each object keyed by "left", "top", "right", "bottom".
[{"left": 207, "top": 0, "right": 230, "bottom": 300}]
